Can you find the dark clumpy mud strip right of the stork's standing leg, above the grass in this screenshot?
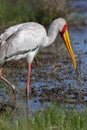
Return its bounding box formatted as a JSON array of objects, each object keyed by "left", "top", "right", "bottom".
[{"left": 39, "top": 87, "right": 87, "bottom": 104}]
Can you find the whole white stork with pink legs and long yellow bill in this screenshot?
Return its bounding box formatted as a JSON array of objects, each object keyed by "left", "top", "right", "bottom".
[{"left": 0, "top": 18, "right": 76, "bottom": 97}]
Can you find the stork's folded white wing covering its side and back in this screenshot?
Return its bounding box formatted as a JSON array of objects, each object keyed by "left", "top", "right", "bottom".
[{"left": 2, "top": 23, "right": 46, "bottom": 59}]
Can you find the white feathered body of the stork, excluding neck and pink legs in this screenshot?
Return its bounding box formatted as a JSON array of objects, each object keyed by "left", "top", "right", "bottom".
[{"left": 0, "top": 22, "right": 46, "bottom": 63}]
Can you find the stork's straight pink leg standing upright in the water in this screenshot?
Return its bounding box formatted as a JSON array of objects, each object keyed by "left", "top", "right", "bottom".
[{"left": 26, "top": 64, "right": 31, "bottom": 97}]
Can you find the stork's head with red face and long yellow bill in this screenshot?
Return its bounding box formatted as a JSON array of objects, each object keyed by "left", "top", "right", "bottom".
[{"left": 59, "top": 18, "right": 76, "bottom": 69}]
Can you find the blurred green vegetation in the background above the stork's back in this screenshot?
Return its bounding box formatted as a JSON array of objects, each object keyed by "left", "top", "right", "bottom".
[{"left": 0, "top": 0, "right": 65, "bottom": 27}]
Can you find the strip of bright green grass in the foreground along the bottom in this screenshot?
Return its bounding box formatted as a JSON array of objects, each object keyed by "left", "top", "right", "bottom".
[{"left": 0, "top": 104, "right": 87, "bottom": 130}]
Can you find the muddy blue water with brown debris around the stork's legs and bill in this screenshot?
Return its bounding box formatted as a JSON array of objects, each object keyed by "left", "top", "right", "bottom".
[{"left": 0, "top": 0, "right": 87, "bottom": 114}]
